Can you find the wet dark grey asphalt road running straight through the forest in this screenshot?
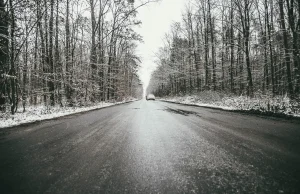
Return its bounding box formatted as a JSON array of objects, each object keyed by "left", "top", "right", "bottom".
[{"left": 0, "top": 100, "right": 300, "bottom": 194}]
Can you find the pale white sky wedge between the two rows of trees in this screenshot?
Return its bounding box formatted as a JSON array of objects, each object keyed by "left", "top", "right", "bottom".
[{"left": 136, "top": 0, "right": 187, "bottom": 92}]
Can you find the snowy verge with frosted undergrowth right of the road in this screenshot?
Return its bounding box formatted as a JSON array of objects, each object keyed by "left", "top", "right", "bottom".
[{"left": 159, "top": 92, "right": 300, "bottom": 117}]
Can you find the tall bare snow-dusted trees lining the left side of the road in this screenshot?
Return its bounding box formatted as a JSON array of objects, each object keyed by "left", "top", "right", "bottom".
[{"left": 0, "top": 0, "right": 142, "bottom": 114}]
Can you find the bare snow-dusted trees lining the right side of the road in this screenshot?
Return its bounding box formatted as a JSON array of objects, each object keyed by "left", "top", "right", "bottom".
[{"left": 148, "top": 0, "right": 300, "bottom": 99}]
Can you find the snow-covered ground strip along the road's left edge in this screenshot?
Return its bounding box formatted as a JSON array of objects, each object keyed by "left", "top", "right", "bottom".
[{"left": 0, "top": 99, "right": 136, "bottom": 129}]
